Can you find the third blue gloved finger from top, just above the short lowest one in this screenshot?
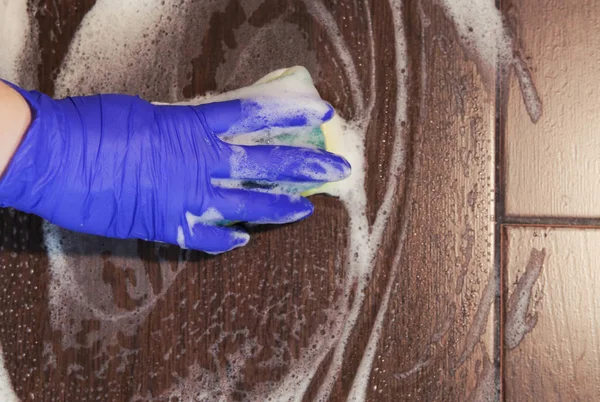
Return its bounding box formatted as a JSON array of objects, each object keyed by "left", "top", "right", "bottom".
[{"left": 195, "top": 188, "right": 314, "bottom": 226}]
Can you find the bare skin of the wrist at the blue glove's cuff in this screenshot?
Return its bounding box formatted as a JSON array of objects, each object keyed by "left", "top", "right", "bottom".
[{"left": 0, "top": 81, "right": 31, "bottom": 178}]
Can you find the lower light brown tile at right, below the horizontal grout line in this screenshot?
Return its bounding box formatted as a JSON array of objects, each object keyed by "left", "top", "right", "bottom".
[{"left": 503, "top": 227, "right": 600, "bottom": 402}]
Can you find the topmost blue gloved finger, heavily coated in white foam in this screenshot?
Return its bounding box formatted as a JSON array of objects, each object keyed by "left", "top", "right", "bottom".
[{"left": 195, "top": 96, "right": 335, "bottom": 136}]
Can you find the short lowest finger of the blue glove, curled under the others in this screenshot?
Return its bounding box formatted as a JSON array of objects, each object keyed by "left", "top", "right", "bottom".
[{"left": 177, "top": 219, "right": 250, "bottom": 254}]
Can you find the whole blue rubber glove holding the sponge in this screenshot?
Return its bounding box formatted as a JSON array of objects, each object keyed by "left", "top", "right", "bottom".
[{"left": 0, "top": 83, "right": 350, "bottom": 253}]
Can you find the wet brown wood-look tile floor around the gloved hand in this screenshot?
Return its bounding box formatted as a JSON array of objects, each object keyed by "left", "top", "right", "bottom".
[{"left": 0, "top": 0, "right": 600, "bottom": 402}]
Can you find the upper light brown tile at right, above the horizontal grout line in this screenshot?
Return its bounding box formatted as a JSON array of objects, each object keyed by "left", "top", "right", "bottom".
[{"left": 505, "top": 0, "right": 600, "bottom": 217}]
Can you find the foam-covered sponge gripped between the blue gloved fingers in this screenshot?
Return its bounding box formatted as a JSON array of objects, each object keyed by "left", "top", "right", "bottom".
[{"left": 173, "top": 66, "right": 345, "bottom": 196}]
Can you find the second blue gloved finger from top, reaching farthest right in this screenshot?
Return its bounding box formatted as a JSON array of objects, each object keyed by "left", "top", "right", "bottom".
[{"left": 211, "top": 145, "right": 351, "bottom": 182}]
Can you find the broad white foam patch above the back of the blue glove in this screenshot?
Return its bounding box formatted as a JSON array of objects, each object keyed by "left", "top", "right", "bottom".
[{"left": 55, "top": 0, "right": 218, "bottom": 100}]
